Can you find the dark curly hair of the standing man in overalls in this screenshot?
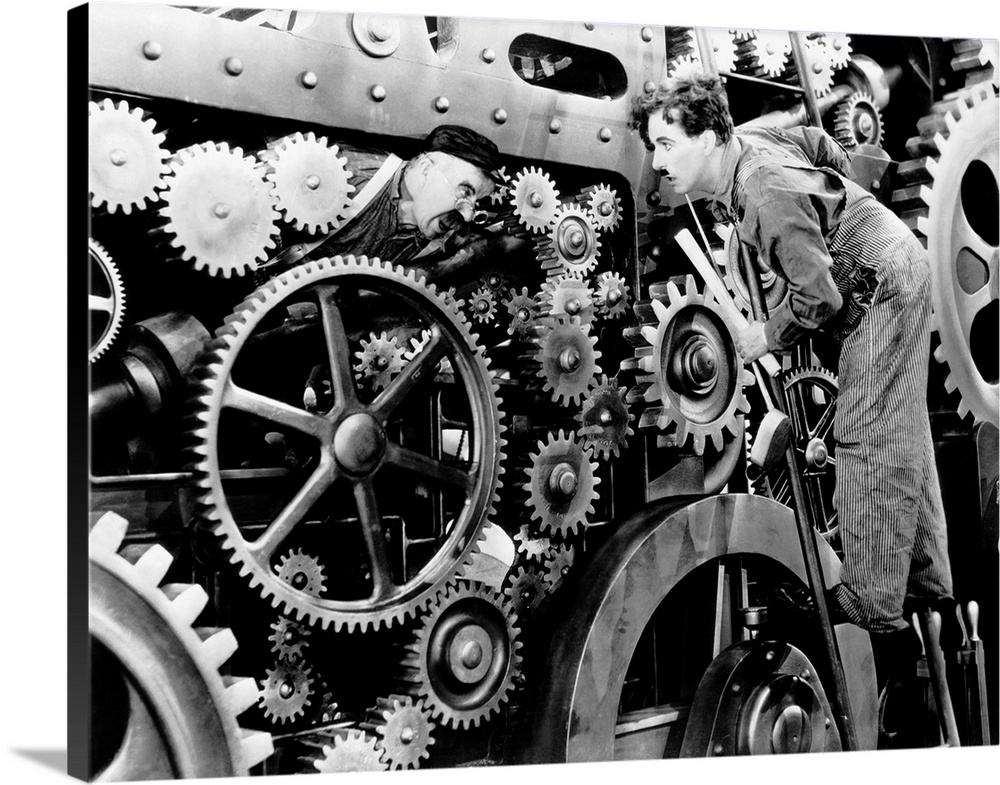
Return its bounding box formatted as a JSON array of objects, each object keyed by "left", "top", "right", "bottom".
[{"left": 630, "top": 71, "right": 733, "bottom": 149}]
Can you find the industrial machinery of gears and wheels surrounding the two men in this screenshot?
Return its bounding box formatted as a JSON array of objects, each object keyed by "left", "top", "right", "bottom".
[{"left": 78, "top": 4, "right": 1000, "bottom": 780}]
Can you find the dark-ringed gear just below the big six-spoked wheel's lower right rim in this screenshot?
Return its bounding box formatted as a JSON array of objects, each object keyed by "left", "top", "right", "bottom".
[{"left": 402, "top": 581, "right": 521, "bottom": 729}]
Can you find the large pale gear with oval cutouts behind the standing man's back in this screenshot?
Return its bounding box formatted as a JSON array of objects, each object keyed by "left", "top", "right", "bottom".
[{"left": 893, "top": 85, "right": 1000, "bottom": 425}]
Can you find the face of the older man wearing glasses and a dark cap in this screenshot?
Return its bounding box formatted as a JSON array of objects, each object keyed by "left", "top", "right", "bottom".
[{"left": 412, "top": 152, "right": 493, "bottom": 239}]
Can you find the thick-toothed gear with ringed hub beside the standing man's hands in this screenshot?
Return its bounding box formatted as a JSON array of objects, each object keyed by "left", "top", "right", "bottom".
[{"left": 636, "top": 275, "right": 753, "bottom": 455}]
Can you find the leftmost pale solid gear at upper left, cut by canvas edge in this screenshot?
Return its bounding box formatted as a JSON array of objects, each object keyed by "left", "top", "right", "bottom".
[{"left": 88, "top": 98, "right": 170, "bottom": 215}]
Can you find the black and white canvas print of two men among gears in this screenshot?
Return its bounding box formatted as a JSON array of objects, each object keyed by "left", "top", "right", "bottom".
[{"left": 37, "top": 3, "right": 1000, "bottom": 782}]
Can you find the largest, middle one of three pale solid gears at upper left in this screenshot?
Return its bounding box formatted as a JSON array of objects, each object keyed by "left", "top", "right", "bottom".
[{"left": 160, "top": 142, "right": 279, "bottom": 278}]
